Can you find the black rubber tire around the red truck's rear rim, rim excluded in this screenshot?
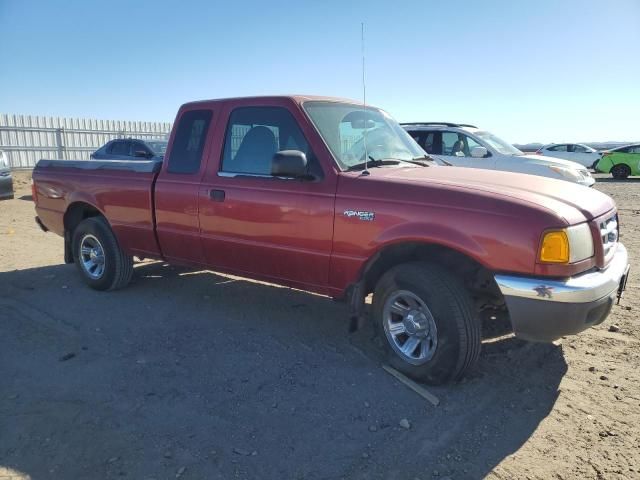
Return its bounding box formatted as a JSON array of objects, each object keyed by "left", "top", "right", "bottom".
[{"left": 72, "top": 217, "right": 133, "bottom": 290}]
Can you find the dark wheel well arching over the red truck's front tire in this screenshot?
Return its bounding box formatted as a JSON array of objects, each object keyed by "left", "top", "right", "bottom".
[{"left": 361, "top": 243, "right": 505, "bottom": 311}]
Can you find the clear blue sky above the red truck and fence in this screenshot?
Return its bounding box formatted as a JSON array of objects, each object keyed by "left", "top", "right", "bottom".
[{"left": 0, "top": 0, "right": 640, "bottom": 142}]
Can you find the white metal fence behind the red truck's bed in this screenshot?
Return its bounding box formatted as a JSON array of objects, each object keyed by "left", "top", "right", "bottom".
[{"left": 0, "top": 114, "right": 171, "bottom": 168}]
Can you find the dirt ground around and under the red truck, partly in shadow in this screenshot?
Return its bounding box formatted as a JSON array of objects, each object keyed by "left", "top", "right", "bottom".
[{"left": 0, "top": 174, "right": 640, "bottom": 480}]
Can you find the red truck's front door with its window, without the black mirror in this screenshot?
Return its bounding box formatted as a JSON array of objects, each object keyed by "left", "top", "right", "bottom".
[{"left": 200, "top": 100, "right": 336, "bottom": 291}]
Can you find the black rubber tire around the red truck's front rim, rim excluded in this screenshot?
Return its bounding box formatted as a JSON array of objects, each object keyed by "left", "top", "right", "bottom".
[{"left": 372, "top": 262, "right": 481, "bottom": 385}]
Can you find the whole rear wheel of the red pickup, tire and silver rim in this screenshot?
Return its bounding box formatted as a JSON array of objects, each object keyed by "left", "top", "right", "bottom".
[{"left": 72, "top": 217, "right": 133, "bottom": 290}]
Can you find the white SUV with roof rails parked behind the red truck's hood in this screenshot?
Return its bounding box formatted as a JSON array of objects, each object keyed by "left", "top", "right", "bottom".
[{"left": 401, "top": 122, "right": 595, "bottom": 187}]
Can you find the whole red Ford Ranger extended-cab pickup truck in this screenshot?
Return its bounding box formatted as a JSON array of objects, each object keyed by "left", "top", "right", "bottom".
[{"left": 33, "top": 96, "right": 629, "bottom": 383}]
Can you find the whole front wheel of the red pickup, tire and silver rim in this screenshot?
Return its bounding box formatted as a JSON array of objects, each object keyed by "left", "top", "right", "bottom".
[{"left": 373, "top": 262, "right": 480, "bottom": 385}]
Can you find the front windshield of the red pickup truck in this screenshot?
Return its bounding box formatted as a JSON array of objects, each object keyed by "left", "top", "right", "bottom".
[{"left": 303, "top": 101, "right": 428, "bottom": 170}]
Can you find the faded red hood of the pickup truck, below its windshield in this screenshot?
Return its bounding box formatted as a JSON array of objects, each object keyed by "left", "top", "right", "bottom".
[{"left": 362, "top": 166, "right": 615, "bottom": 225}]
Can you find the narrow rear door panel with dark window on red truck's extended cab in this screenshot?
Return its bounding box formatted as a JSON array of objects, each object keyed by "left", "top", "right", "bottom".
[{"left": 155, "top": 109, "right": 213, "bottom": 264}]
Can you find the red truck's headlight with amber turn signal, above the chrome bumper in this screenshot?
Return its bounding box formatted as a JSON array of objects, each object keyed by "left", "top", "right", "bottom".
[{"left": 538, "top": 223, "right": 594, "bottom": 263}]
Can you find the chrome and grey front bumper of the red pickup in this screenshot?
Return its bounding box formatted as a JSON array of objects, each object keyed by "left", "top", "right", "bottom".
[{"left": 495, "top": 243, "right": 629, "bottom": 342}]
